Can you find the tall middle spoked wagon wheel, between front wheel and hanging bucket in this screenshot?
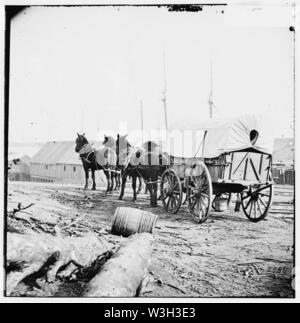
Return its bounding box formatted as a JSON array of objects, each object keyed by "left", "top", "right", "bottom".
[{"left": 187, "top": 162, "right": 213, "bottom": 224}]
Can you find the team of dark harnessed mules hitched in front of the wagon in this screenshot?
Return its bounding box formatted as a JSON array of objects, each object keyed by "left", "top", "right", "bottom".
[{"left": 75, "top": 134, "right": 168, "bottom": 206}]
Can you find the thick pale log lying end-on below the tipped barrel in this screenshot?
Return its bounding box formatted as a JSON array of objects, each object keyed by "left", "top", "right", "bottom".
[{"left": 84, "top": 233, "right": 153, "bottom": 297}]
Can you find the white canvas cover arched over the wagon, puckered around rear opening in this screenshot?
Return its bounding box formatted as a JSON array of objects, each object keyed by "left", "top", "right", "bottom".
[{"left": 172, "top": 115, "right": 273, "bottom": 158}]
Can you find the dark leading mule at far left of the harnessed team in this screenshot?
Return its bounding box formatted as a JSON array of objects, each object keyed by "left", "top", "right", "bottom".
[{"left": 75, "top": 133, "right": 117, "bottom": 193}]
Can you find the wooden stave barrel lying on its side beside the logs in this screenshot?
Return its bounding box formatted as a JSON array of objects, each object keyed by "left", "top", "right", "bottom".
[{"left": 111, "top": 207, "right": 157, "bottom": 237}]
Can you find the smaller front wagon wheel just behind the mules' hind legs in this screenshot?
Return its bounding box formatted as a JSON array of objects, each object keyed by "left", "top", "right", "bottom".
[{"left": 160, "top": 169, "right": 182, "bottom": 214}]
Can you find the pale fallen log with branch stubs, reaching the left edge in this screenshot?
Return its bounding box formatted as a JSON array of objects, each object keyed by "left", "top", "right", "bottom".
[{"left": 6, "top": 233, "right": 112, "bottom": 296}]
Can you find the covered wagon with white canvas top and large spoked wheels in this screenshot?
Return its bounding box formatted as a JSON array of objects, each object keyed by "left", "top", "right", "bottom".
[{"left": 160, "top": 116, "right": 273, "bottom": 223}]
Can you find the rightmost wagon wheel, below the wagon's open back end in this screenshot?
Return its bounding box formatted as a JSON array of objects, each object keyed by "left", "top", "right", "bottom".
[{"left": 241, "top": 184, "right": 273, "bottom": 222}]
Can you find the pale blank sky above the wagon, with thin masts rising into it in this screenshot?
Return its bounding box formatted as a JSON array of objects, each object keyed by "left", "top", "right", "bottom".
[{"left": 9, "top": 5, "right": 294, "bottom": 146}]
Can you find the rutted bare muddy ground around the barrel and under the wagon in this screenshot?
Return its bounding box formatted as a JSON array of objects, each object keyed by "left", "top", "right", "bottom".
[{"left": 8, "top": 182, "right": 294, "bottom": 297}]
